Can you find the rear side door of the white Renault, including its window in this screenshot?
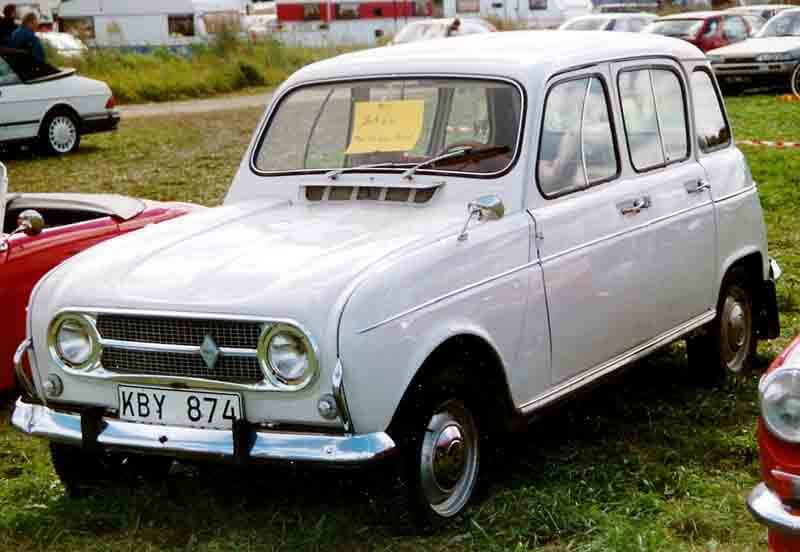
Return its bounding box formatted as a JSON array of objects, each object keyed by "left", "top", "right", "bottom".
[{"left": 612, "top": 59, "right": 716, "bottom": 337}]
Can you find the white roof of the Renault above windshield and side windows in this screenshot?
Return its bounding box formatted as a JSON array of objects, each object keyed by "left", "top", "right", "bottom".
[{"left": 285, "top": 31, "right": 706, "bottom": 86}]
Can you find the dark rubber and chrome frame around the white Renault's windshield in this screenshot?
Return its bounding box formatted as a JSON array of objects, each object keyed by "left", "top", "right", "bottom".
[{"left": 245, "top": 72, "right": 528, "bottom": 180}]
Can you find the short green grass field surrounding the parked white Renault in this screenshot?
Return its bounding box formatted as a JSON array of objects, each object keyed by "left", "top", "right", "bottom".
[{"left": 0, "top": 92, "right": 800, "bottom": 552}]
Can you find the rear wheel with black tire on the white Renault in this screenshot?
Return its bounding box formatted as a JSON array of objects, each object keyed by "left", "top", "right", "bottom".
[{"left": 686, "top": 267, "right": 758, "bottom": 385}]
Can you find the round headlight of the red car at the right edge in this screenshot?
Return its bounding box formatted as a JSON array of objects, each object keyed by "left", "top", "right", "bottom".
[{"left": 761, "top": 368, "right": 800, "bottom": 443}]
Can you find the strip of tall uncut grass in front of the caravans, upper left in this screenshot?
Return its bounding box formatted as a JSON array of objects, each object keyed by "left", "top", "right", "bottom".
[{"left": 51, "top": 38, "right": 344, "bottom": 103}]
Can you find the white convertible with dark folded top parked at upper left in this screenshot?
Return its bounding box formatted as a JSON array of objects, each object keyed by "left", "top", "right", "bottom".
[{"left": 0, "top": 48, "right": 120, "bottom": 155}]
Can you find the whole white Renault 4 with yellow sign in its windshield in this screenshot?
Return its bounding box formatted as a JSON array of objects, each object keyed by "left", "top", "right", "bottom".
[{"left": 12, "top": 31, "right": 778, "bottom": 523}]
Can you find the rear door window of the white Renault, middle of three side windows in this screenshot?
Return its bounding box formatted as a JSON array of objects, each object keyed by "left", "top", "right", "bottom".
[{"left": 619, "top": 69, "right": 690, "bottom": 172}]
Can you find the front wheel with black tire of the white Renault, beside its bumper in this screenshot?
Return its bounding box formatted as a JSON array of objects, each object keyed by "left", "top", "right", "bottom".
[{"left": 392, "top": 370, "right": 485, "bottom": 532}]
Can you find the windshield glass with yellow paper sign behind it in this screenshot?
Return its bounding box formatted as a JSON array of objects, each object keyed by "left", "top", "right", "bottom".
[{"left": 254, "top": 78, "right": 522, "bottom": 174}]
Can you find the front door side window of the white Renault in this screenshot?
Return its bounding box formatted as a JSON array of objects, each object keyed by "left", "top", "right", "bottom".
[{"left": 537, "top": 77, "right": 619, "bottom": 198}]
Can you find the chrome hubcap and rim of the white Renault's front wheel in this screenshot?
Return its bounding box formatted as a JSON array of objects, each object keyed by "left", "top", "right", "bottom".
[{"left": 420, "top": 401, "right": 478, "bottom": 517}]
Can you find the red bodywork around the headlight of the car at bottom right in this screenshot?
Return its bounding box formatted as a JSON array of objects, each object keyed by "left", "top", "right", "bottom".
[{"left": 758, "top": 336, "right": 800, "bottom": 552}]
